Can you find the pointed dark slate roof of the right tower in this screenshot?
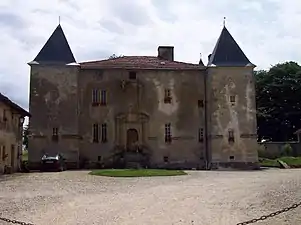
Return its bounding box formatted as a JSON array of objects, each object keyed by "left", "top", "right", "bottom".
[{"left": 208, "top": 26, "right": 253, "bottom": 66}]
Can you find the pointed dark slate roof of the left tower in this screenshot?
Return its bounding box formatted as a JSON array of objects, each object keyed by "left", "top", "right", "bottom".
[{"left": 34, "top": 25, "right": 76, "bottom": 64}]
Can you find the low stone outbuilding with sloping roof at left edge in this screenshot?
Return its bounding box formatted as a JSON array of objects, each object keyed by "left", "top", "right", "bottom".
[{"left": 0, "top": 93, "right": 30, "bottom": 174}]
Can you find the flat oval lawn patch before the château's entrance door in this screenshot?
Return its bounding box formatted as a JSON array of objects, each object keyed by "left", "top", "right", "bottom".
[{"left": 89, "top": 169, "right": 187, "bottom": 177}]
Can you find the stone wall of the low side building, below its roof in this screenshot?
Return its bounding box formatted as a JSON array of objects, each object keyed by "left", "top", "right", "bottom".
[{"left": 0, "top": 102, "right": 22, "bottom": 174}]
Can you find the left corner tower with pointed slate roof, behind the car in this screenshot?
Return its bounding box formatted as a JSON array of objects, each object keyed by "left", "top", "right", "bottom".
[{"left": 28, "top": 25, "right": 79, "bottom": 167}]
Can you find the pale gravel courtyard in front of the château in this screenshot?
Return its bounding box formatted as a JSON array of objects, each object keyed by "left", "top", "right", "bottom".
[{"left": 0, "top": 169, "right": 301, "bottom": 225}]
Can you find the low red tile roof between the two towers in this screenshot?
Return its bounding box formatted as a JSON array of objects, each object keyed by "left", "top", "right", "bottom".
[{"left": 80, "top": 56, "right": 204, "bottom": 70}]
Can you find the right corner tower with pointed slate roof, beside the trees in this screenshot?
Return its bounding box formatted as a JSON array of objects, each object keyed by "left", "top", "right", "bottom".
[{"left": 206, "top": 26, "right": 258, "bottom": 168}]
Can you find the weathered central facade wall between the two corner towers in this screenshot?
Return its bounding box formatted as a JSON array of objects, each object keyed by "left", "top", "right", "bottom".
[{"left": 79, "top": 69, "right": 204, "bottom": 167}]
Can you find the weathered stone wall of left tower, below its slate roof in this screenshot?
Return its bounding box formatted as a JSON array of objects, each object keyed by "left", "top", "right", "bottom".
[{"left": 28, "top": 65, "right": 79, "bottom": 166}]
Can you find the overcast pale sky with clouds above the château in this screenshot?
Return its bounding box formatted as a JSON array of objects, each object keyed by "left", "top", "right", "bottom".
[{"left": 0, "top": 0, "right": 301, "bottom": 109}]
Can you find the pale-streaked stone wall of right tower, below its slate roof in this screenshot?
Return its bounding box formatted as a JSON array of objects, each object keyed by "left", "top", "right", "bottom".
[{"left": 207, "top": 67, "right": 258, "bottom": 168}]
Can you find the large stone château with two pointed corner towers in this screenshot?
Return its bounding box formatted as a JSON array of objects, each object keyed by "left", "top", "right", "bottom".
[{"left": 29, "top": 25, "right": 258, "bottom": 169}]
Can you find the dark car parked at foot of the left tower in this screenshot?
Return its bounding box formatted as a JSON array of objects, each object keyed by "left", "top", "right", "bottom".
[{"left": 41, "top": 154, "right": 66, "bottom": 172}]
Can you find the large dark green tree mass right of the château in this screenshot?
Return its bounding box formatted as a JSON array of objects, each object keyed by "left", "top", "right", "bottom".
[{"left": 255, "top": 62, "right": 301, "bottom": 141}]
